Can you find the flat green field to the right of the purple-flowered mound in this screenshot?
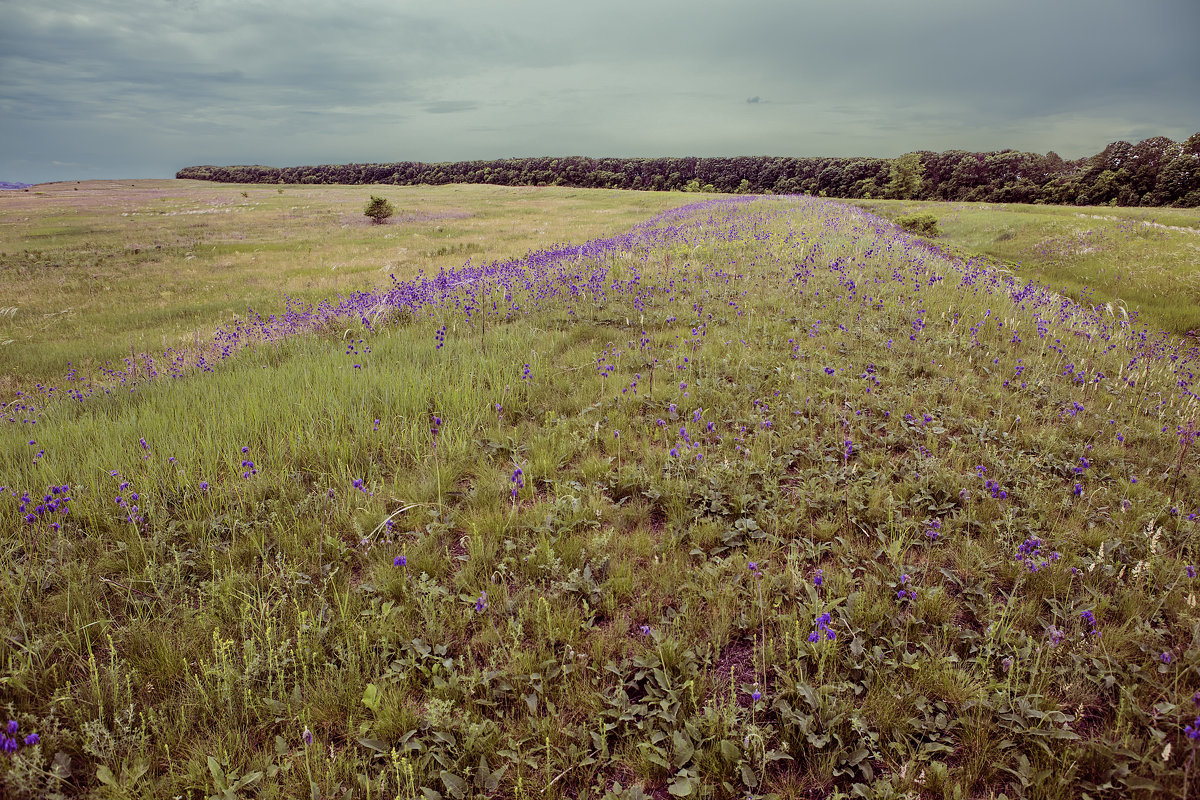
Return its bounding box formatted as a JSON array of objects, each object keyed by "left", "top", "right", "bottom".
[{"left": 854, "top": 200, "right": 1200, "bottom": 335}]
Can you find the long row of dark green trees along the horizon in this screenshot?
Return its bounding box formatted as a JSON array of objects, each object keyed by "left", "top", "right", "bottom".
[{"left": 175, "top": 133, "right": 1200, "bottom": 206}]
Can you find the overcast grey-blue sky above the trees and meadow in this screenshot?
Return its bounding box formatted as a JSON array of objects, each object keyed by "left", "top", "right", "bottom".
[{"left": 0, "top": 0, "right": 1200, "bottom": 182}]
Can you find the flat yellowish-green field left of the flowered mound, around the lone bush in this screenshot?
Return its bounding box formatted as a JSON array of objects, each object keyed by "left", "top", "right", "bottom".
[{"left": 0, "top": 180, "right": 695, "bottom": 397}]
